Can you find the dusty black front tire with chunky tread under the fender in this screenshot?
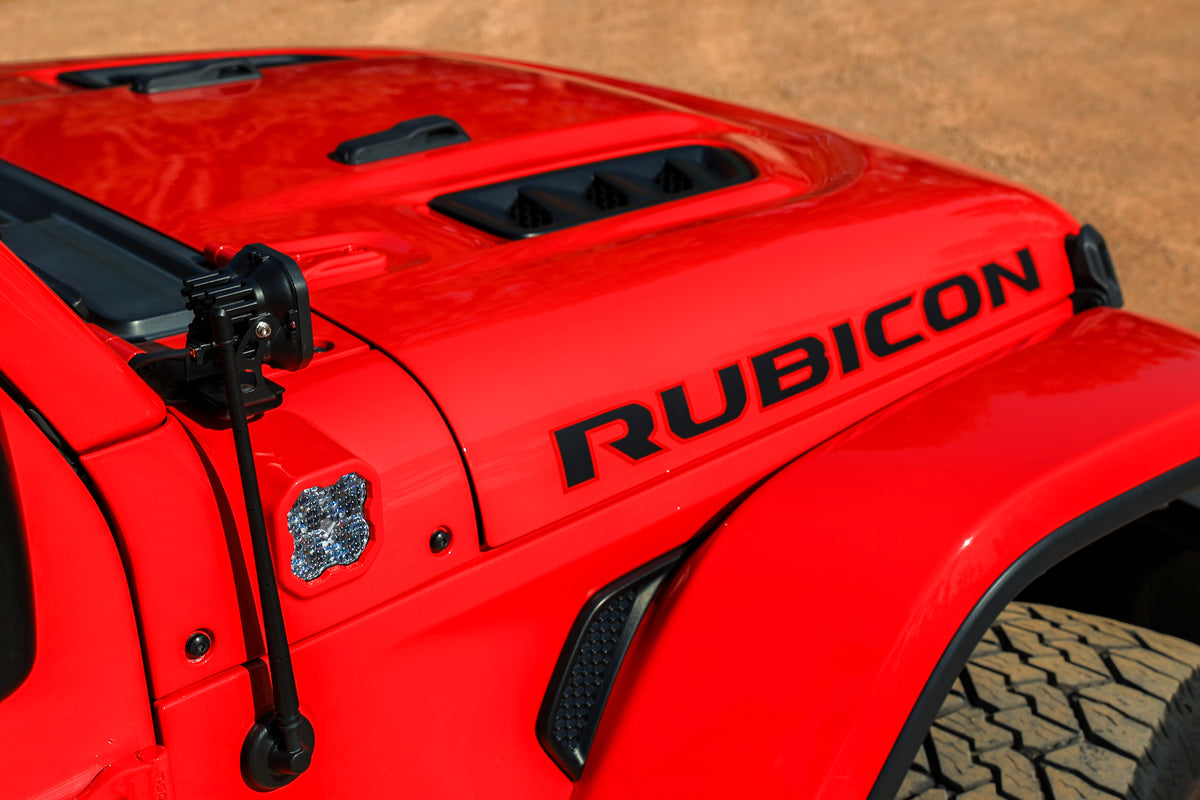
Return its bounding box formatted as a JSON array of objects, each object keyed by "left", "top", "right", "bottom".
[{"left": 896, "top": 603, "right": 1200, "bottom": 800}]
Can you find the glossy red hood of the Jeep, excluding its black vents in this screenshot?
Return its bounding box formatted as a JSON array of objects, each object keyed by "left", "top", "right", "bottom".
[{"left": 0, "top": 54, "right": 1078, "bottom": 543}]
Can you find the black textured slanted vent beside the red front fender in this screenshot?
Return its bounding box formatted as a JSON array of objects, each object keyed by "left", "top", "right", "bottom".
[{"left": 538, "top": 548, "right": 683, "bottom": 781}]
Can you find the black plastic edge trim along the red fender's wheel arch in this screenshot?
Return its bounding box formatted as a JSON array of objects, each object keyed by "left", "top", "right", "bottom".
[{"left": 868, "top": 458, "right": 1200, "bottom": 800}]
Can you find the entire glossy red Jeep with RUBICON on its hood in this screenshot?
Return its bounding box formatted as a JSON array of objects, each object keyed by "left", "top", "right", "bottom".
[{"left": 0, "top": 50, "right": 1200, "bottom": 800}]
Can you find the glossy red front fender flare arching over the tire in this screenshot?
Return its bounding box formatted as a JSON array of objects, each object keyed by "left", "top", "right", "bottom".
[{"left": 576, "top": 309, "right": 1200, "bottom": 800}]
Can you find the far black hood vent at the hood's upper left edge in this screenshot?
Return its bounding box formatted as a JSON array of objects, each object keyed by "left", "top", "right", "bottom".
[{"left": 59, "top": 53, "right": 344, "bottom": 95}]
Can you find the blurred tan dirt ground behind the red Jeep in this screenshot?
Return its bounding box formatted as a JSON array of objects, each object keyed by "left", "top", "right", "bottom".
[{"left": 0, "top": 0, "right": 1200, "bottom": 330}]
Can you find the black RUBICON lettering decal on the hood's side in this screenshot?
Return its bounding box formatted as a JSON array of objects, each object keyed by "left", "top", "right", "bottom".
[{"left": 551, "top": 248, "right": 1042, "bottom": 489}]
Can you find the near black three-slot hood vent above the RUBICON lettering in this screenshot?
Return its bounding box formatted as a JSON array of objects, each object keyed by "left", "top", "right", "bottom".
[{"left": 430, "top": 145, "right": 756, "bottom": 239}]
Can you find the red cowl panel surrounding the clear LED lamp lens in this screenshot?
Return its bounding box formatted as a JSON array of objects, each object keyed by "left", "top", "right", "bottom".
[{"left": 171, "top": 345, "right": 479, "bottom": 662}]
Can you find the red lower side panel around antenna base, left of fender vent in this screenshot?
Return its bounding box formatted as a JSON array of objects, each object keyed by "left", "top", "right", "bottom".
[{"left": 156, "top": 431, "right": 730, "bottom": 800}]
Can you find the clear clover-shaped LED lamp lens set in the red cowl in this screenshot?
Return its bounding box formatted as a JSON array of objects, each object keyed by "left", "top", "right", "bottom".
[{"left": 288, "top": 473, "right": 371, "bottom": 581}]
